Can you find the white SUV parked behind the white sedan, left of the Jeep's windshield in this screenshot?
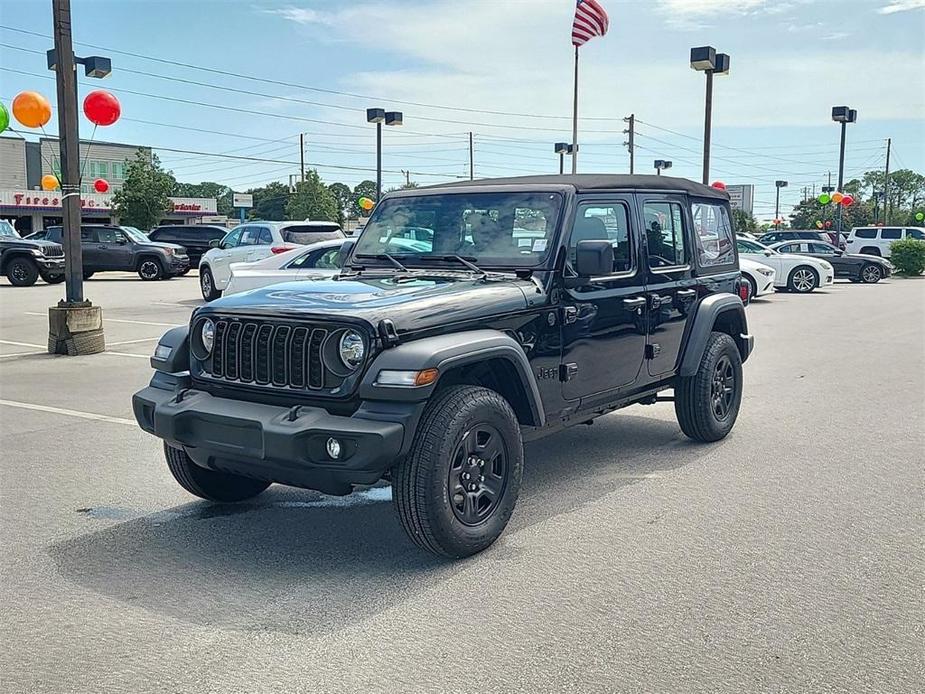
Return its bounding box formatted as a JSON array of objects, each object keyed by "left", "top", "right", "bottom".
[{"left": 199, "top": 221, "right": 344, "bottom": 301}]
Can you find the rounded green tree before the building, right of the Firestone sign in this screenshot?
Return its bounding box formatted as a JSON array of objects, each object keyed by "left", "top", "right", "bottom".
[{"left": 112, "top": 152, "right": 177, "bottom": 229}]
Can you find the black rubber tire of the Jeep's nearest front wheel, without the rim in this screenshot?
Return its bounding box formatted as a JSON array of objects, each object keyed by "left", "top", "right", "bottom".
[{"left": 392, "top": 385, "right": 523, "bottom": 559}]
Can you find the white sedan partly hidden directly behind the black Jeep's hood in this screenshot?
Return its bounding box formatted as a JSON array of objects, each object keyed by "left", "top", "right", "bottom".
[{"left": 223, "top": 239, "right": 343, "bottom": 296}]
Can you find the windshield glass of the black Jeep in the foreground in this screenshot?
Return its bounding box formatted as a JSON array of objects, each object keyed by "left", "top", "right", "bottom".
[{"left": 354, "top": 193, "right": 562, "bottom": 267}]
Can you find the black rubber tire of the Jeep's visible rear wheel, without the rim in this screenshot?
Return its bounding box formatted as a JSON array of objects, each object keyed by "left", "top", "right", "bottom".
[{"left": 674, "top": 332, "right": 742, "bottom": 442}]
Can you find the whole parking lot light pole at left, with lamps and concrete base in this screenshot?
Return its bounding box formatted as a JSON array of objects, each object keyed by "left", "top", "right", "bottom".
[{"left": 47, "top": 0, "right": 112, "bottom": 355}]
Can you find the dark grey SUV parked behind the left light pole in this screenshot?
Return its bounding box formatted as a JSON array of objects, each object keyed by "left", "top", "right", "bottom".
[{"left": 47, "top": 224, "right": 189, "bottom": 280}]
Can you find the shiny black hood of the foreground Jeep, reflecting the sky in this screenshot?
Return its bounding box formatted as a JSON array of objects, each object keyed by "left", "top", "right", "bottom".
[{"left": 200, "top": 273, "right": 540, "bottom": 333}]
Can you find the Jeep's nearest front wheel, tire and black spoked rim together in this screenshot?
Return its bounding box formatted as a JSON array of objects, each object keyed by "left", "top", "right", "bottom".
[{"left": 392, "top": 386, "right": 523, "bottom": 559}]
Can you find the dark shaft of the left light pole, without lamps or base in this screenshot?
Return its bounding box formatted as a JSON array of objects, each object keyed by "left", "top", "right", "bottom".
[{"left": 51, "top": 0, "right": 84, "bottom": 303}]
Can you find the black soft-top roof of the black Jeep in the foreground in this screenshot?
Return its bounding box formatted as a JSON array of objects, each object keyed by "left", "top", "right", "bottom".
[{"left": 422, "top": 174, "right": 729, "bottom": 200}]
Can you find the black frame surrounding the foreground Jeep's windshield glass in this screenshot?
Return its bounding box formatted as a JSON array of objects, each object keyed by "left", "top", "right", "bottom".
[{"left": 344, "top": 184, "right": 574, "bottom": 273}]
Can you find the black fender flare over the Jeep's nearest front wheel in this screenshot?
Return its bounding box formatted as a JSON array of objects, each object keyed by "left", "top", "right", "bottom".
[{"left": 359, "top": 330, "right": 546, "bottom": 426}]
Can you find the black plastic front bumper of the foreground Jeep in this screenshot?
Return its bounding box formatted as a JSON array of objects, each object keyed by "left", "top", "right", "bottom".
[{"left": 132, "top": 386, "right": 423, "bottom": 493}]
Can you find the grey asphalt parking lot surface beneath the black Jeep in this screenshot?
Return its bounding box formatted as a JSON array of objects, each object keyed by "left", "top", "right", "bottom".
[{"left": 0, "top": 272, "right": 925, "bottom": 693}]
